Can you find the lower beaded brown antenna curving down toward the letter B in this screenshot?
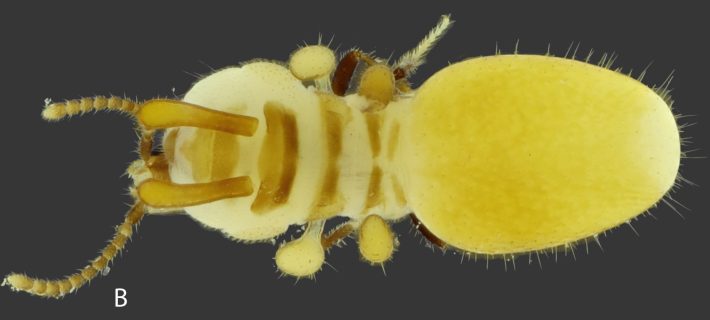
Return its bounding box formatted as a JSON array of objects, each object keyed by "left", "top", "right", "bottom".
[{"left": 2, "top": 201, "right": 145, "bottom": 298}]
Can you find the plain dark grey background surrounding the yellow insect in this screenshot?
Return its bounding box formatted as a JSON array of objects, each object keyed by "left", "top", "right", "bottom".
[{"left": 0, "top": 1, "right": 710, "bottom": 319}]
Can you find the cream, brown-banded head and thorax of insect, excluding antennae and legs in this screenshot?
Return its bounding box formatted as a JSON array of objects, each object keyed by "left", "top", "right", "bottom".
[{"left": 163, "top": 62, "right": 408, "bottom": 240}]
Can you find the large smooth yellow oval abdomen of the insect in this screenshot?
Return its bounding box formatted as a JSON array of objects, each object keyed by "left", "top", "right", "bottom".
[{"left": 402, "top": 55, "right": 680, "bottom": 254}]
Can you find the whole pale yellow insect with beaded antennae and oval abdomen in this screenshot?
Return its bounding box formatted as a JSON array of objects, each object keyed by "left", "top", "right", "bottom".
[{"left": 4, "top": 16, "right": 681, "bottom": 298}]
